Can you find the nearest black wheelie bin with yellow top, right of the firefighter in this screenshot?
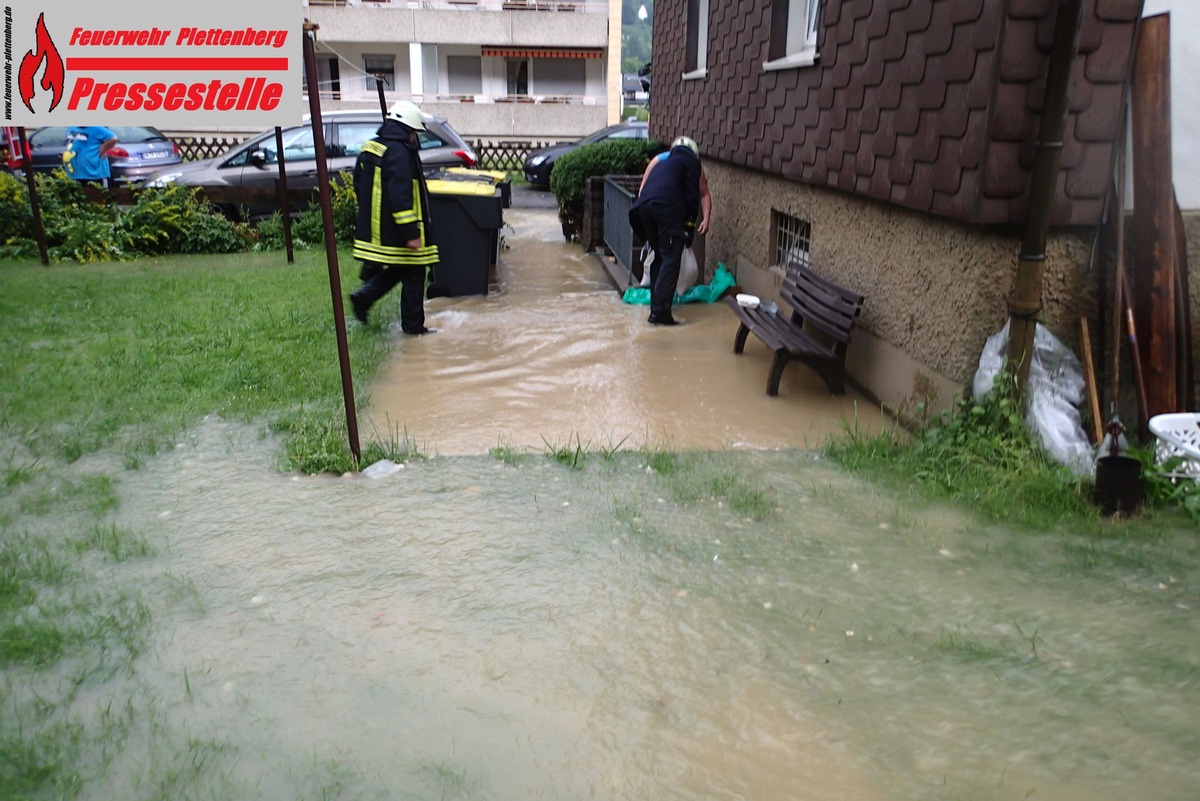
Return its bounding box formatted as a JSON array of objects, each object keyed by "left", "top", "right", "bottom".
[{"left": 428, "top": 180, "right": 504, "bottom": 297}]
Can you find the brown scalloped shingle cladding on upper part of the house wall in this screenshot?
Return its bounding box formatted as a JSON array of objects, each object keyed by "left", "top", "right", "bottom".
[{"left": 650, "top": 0, "right": 1142, "bottom": 225}]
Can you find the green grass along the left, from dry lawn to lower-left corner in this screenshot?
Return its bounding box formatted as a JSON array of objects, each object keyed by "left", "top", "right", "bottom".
[{"left": 0, "top": 251, "right": 403, "bottom": 800}]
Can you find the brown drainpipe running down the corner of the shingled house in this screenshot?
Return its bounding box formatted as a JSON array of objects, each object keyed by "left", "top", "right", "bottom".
[{"left": 1008, "top": 0, "right": 1084, "bottom": 392}]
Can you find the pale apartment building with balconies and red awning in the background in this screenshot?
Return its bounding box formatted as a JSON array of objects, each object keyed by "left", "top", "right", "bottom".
[{"left": 305, "top": 0, "right": 620, "bottom": 140}]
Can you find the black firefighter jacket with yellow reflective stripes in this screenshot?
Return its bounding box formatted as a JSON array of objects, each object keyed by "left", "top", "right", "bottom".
[{"left": 354, "top": 120, "right": 438, "bottom": 265}]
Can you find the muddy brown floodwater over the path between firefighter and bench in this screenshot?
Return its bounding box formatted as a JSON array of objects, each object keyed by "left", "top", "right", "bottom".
[{"left": 364, "top": 209, "right": 881, "bottom": 454}]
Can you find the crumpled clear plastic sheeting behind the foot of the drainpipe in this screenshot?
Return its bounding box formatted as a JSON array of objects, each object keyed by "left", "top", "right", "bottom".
[{"left": 971, "top": 321, "right": 1096, "bottom": 476}]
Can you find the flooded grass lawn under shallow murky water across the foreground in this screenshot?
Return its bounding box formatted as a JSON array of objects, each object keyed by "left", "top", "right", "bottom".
[{"left": 0, "top": 421, "right": 1200, "bottom": 801}]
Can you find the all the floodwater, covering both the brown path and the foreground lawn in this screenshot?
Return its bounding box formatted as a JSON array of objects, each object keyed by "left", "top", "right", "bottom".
[{"left": 11, "top": 203, "right": 1200, "bottom": 801}]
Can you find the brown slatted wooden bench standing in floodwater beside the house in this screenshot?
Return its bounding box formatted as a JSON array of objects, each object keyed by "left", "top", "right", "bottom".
[{"left": 725, "top": 265, "right": 863, "bottom": 396}]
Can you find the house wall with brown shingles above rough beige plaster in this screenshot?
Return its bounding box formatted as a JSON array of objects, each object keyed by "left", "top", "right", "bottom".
[{"left": 650, "top": 0, "right": 1142, "bottom": 415}]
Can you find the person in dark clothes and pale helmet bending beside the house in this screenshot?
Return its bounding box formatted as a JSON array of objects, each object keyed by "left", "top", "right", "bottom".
[{"left": 629, "top": 137, "right": 713, "bottom": 325}]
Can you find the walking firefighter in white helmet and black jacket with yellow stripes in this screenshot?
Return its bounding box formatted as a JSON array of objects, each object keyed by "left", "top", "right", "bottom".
[{"left": 350, "top": 101, "right": 438, "bottom": 336}]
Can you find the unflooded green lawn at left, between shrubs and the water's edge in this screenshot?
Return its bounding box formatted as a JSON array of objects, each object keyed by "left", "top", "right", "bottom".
[{"left": 0, "top": 251, "right": 388, "bottom": 472}]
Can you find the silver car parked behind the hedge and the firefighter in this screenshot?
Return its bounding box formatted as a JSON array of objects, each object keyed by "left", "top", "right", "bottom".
[{"left": 141, "top": 112, "right": 478, "bottom": 219}]
